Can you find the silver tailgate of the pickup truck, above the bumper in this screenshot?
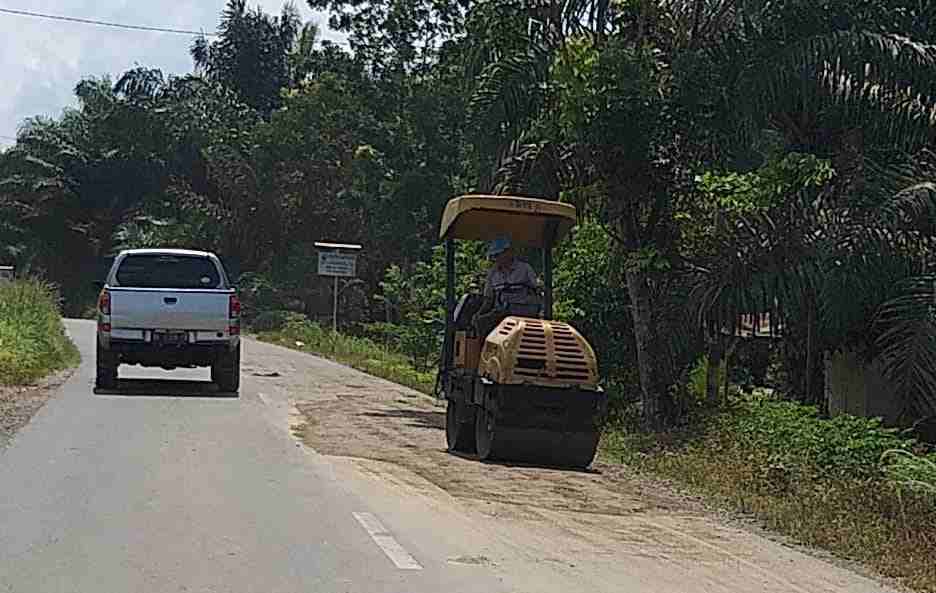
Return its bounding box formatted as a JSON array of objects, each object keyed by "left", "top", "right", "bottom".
[{"left": 110, "top": 287, "right": 234, "bottom": 332}]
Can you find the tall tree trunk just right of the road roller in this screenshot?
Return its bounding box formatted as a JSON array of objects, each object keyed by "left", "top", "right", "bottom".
[{"left": 626, "top": 268, "right": 662, "bottom": 428}]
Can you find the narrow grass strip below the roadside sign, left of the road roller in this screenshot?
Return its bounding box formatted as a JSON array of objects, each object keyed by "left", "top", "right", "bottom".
[{"left": 254, "top": 315, "right": 435, "bottom": 394}]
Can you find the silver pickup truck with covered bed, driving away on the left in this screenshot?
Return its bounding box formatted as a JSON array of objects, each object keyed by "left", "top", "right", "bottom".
[{"left": 95, "top": 249, "right": 241, "bottom": 393}]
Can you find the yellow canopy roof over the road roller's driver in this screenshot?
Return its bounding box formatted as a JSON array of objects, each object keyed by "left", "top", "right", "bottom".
[{"left": 439, "top": 195, "right": 575, "bottom": 247}]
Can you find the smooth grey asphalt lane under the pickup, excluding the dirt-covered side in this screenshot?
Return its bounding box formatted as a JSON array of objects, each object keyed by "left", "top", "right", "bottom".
[{"left": 0, "top": 322, "right": 511, "bottom": 593}]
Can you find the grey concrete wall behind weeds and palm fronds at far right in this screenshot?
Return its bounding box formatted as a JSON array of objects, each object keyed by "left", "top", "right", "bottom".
[{"left": 825, "top": 352, "right": 902, "bottom": 424}]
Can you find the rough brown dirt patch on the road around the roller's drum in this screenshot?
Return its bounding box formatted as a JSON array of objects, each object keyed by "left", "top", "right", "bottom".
[{"left": 293, "top": 390, "right": 701, "bottom": 515}]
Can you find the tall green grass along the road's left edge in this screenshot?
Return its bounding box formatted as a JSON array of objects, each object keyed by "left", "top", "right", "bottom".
[{"left": 0, "top": 280, "right": 79, "bottom": 385}]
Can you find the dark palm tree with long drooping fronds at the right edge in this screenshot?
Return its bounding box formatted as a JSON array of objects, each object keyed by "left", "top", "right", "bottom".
[{"left": 680, "top": 2, "right": 936, "bottom": 416}]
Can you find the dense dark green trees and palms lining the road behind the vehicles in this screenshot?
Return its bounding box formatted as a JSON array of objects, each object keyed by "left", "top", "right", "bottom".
[{"left": 0, "top": 0, "right": 936, "bottom": 424}]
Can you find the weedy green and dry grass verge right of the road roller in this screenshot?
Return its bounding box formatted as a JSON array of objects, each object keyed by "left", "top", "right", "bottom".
[{"left": 603, "top": 397, "right": 936, "bottom": 593}]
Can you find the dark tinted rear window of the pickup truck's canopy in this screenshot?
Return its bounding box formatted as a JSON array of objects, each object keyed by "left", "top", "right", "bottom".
[{"left": 117, "top": 255, "right": 221, "bottom": 288}]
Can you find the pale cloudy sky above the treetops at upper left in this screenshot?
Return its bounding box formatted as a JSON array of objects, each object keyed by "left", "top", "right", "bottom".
[{"left": 0, "top": 0, "right": 342, "bottom": 149}]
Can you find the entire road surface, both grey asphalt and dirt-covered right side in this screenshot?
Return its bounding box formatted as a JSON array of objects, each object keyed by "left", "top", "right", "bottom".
[{"left": 0, "top": 321, "right": 904, "bottom": 593}]
